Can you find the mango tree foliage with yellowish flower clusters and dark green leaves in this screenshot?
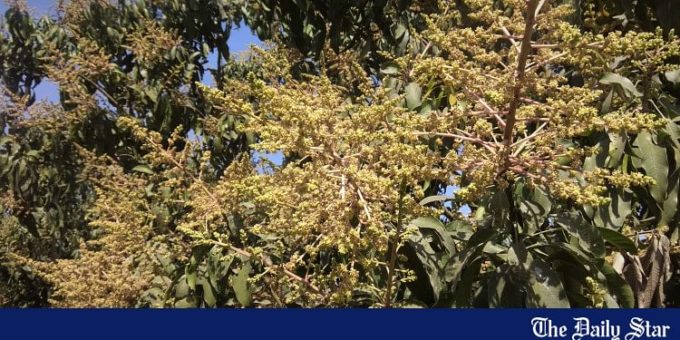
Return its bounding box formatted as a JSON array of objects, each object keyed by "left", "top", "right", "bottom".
[{"left": 0, "top": 0, "right": 680, "bottom": 308}]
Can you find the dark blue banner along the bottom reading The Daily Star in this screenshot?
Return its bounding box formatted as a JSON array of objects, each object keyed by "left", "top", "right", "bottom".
[{"left": 0, "top": 309, "right": 680, "bottom": 340}]
